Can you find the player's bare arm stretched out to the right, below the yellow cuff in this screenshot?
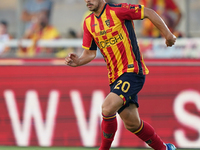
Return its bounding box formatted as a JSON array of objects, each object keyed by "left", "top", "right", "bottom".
[{"left": 144, "top": 7, "right": 176, "bottom": 46}]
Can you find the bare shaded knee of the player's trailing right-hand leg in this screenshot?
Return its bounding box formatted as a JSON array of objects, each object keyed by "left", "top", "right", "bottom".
[{"left": 119, "top": 104, "right": 141, "bottom": 131}]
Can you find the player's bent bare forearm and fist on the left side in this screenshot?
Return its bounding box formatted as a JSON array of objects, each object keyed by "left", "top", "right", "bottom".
[{"left": 65, "top": 50, "right": 96, "bottom": 67}]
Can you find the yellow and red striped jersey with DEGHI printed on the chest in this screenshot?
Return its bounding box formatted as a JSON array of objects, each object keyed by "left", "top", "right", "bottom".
[{"left": 82, "top": 3, "right": 149, "bottom": 84}]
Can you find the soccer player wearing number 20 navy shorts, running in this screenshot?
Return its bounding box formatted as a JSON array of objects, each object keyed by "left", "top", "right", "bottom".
[{"left": 65, "top": 0, "right": 176, "bottom": 150}]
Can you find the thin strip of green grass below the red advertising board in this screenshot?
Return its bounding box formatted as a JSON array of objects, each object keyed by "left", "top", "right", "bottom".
[{"left": 0, "top": 146, "right": 197, "bottom": 150}]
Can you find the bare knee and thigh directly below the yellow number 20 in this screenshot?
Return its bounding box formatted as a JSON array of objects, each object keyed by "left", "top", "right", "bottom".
[{"left": 102, "top": 92, "right": 124, "bottom": 116}]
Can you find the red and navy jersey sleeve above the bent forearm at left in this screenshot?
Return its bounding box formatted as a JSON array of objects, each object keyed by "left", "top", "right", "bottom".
[{"left": 82, "top": 21, "right": 97, "bottom": 50}]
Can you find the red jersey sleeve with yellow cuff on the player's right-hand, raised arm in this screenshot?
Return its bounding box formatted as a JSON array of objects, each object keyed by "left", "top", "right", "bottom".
[{"left": 117, "top": 3, "right": 144, "bottom": 20}]
